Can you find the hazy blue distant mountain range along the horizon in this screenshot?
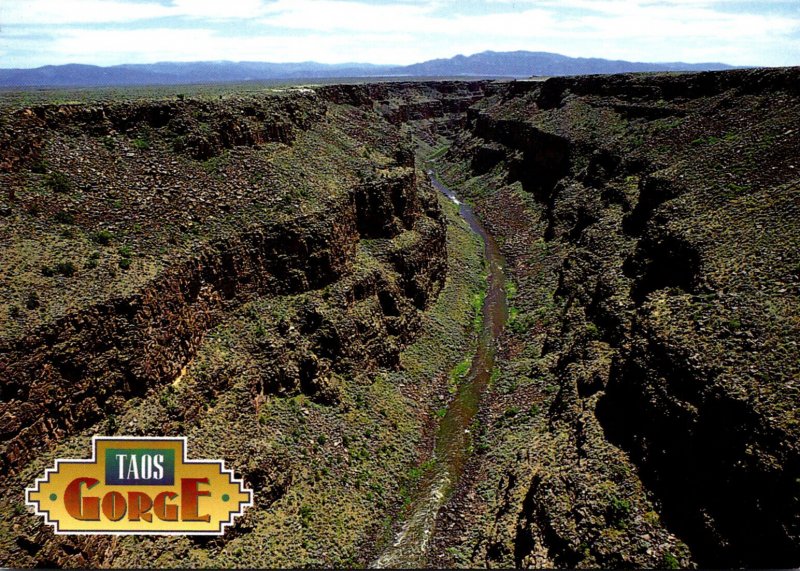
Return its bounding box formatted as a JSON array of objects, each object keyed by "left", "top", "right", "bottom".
[{"left": 0, "top": 51, "right": 732, "bottom": 88}]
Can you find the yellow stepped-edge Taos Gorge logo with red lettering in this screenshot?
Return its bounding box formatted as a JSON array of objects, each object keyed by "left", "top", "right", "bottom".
[{"left": 25, "top": 436, "right": 253, "bottom": 535}]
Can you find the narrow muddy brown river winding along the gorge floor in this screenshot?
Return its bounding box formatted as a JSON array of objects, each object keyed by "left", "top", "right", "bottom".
[{"left": 372, "top": 177, "right": 508, "bottom": 568}]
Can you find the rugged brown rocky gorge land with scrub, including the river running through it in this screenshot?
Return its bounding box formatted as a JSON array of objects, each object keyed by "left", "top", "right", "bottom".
[{"left": 0, "top": 68, "right": 800, "bottom": 568}]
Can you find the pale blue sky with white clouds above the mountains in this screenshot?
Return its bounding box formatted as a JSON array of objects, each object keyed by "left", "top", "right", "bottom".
[{"left": 0, "top": 0, "right": 800, "bottom": 68}]
